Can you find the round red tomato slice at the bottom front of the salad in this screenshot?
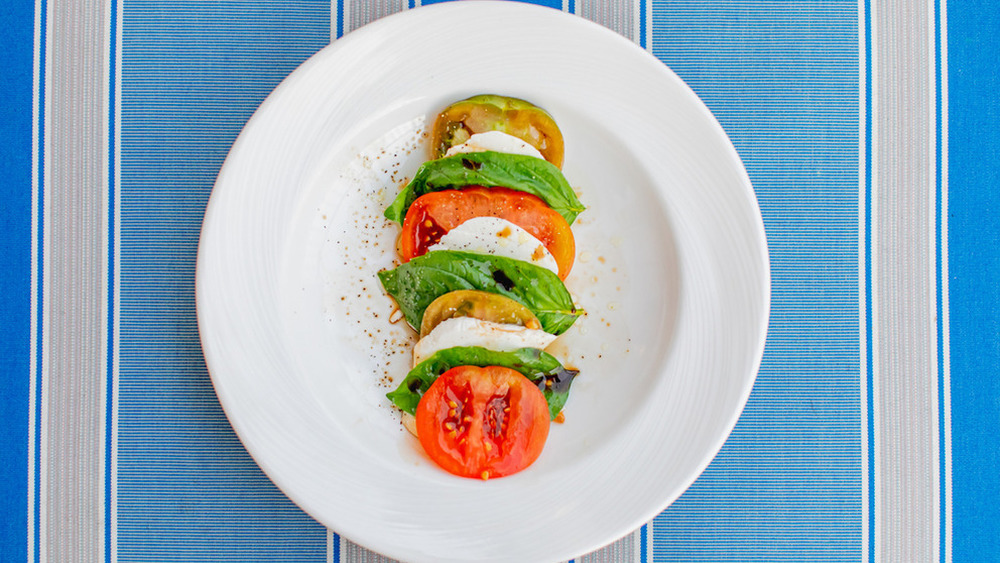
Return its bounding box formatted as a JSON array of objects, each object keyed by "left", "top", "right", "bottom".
[{"left": 416, "top": 366, "right": 549, "bottom": 479}]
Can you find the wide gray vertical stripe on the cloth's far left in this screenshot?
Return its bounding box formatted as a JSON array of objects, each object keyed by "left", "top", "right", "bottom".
[{"left": 39, "top": 0, "right": 107, "bottom": 562}]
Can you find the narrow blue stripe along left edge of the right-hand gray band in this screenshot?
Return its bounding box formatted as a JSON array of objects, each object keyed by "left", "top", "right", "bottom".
[{"left": 861, "top": 0, "right": 876, "bottom": 563}]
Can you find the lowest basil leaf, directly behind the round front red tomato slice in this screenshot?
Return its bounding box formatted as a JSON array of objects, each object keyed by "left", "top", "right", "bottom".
[{"left": 386, "top": 346, "right": 579, "bottom": 418}]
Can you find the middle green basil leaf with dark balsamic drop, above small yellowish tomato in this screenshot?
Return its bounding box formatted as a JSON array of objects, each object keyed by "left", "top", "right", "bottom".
[{"left": 378, "top": 250, "right": 583, "bottom": 335}]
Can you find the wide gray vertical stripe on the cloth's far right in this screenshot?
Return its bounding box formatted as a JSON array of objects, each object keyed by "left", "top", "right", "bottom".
[{"left": 869, "top": 1, "right": 938, "bottom": 561}]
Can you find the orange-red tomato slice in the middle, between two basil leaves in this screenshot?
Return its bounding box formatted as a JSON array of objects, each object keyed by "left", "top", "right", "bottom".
[{"left": 399, "top": 186, "right": 576, "bottom": 279}]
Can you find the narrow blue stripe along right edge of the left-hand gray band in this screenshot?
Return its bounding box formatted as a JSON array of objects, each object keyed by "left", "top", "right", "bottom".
[{"left": 104, "top": 0, "right": 118, "bottom": 563}]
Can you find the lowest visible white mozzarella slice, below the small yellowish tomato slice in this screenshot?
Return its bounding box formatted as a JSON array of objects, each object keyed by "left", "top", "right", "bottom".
[{"left": 413, "top": 317, "right": 556, "bottom": 366}]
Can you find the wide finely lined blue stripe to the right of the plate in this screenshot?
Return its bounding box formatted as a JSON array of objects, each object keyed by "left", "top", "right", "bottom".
[{"left": 649, "top": 0, "right": 868, "bottom": 562}]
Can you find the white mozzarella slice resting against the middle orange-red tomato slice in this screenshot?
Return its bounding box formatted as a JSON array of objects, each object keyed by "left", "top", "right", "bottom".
[{"left": 427, "top": 217, "right": 559, "bottom": 274}]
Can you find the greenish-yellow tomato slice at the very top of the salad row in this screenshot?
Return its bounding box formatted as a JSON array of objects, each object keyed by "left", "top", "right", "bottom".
[{"left": 431, "top": 94, "right": 565, "bottom": 168}]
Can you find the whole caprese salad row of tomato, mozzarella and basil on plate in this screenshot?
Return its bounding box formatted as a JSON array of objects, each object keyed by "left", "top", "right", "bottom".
[{"left": 378, "top": 95, "right": 584, "bottom": 479}]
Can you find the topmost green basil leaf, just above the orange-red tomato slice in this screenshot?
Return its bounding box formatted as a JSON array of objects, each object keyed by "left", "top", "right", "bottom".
[{"left": 385, "top": 151, "right": 586, "bottom": 225}]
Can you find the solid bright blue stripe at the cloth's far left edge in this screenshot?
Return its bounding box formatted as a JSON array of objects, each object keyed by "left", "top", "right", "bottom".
[{"left": 0, "top": 1, "right": 35, "bottom": 561}]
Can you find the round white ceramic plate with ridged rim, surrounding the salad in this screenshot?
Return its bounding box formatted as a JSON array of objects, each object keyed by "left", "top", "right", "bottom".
[{"left": 197, "top": 2, "right": 769, "bottom": 562}]
